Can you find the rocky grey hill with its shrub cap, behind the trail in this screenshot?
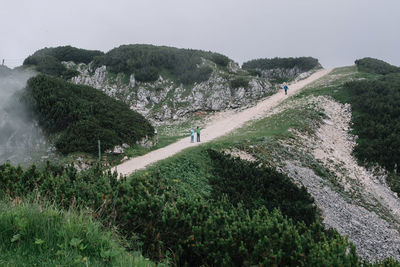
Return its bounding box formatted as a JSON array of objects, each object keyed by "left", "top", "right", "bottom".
[{"left": 24, "top": 44, "right": 318, "bottom": 124}]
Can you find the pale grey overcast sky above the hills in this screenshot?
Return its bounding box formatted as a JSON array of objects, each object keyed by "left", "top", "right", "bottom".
[{"left": 0, "top": 0, "right": 400, "bottom": 67}]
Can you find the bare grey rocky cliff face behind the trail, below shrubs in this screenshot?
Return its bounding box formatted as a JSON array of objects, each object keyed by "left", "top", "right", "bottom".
[{"left": 64, "top": 62, "right": 274, "bottom": 122}]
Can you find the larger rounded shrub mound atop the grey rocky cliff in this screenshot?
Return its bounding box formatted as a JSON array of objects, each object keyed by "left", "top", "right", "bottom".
[{"left": 94, "top": 45, "right": 229, "bottom": 84}]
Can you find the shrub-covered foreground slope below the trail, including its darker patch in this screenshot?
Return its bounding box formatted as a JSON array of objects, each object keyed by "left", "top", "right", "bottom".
[{"left": 0, "top": 156, "right": 359, "bottom": 266}]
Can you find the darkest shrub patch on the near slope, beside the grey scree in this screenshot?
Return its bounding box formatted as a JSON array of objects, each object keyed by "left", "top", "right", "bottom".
[{"left": 209, "top": 150, "right": 316, "bottom": 224}]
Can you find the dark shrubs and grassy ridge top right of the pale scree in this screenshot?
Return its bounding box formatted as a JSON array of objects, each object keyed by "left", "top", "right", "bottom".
[{"left": 296, "top": 61, "right": 400, "bottom": 197}]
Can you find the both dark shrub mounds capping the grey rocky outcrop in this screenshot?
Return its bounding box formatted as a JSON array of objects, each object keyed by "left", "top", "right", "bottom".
[{"left": 24, "top": 44, "right": 230, "bottom": 84}]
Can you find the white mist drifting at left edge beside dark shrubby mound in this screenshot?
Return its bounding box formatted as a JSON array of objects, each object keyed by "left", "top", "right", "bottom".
[{"left": 0, "top": 66, "right": 52, "bottom": 166}]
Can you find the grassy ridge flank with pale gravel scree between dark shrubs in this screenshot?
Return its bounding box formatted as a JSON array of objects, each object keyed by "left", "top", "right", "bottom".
[{"left": 111, "top": 62, "right": 400, "bottom": 266}]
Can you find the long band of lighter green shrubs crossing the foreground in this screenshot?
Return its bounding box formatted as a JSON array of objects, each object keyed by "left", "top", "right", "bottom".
[{"left": 0, "top": 152, "right": 378, "bottom": 266}]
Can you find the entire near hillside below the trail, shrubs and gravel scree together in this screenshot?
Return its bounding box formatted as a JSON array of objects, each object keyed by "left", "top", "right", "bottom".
[{"left": 0, "top": 57, "right": 400, "bottom": 266}]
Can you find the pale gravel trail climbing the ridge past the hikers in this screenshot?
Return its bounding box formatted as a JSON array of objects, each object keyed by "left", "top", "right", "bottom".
[{"left": 112, "top": 69, "right": 331, "bottom": 175}]
